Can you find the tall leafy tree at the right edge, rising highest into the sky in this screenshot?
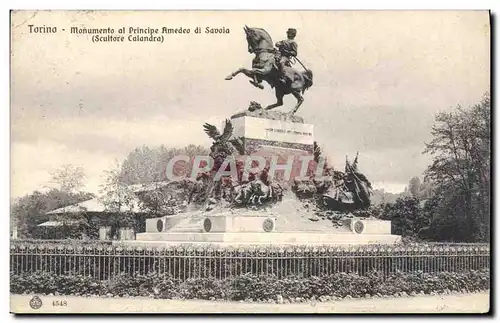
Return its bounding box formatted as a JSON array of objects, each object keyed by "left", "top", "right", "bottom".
[{"left": 424, "top": 93, "right": 491, "bottom": 241}]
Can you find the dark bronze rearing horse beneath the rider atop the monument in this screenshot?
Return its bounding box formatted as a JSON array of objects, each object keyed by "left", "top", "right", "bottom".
[{"left": 226, "top": 26, "right": 313, "bottom": 115}]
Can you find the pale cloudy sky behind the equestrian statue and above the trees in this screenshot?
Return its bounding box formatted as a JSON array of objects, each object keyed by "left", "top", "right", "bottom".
[{"left": 10, "top": 11, "right": 490, "bottom": 197}]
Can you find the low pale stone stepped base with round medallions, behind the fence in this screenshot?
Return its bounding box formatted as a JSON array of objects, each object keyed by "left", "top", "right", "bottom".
[{"left": 121, "top": 214, "right": 401, "bottom": 246}]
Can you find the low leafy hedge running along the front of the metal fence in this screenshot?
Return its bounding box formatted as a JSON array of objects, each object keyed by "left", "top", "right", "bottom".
[{"left": 10, "top": 270, "right": 490, "bottom": 302}]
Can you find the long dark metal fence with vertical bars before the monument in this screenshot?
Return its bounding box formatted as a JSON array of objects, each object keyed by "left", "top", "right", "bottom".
[{"left": 10, "top": 241, "right": 490, "bottom": 280}]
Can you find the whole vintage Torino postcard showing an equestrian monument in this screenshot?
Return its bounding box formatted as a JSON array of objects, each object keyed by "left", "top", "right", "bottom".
[{"left": 9, "top": 10, "right": 492, "bottom": 314}]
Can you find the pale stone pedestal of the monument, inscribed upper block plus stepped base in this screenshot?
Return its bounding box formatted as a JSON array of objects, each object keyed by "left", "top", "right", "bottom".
[{"left": 117, "top": 114, "right": 401, "bottom": 246}]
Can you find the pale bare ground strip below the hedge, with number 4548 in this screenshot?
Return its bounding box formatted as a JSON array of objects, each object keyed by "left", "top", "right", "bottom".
[{"left": 10, "top": 293, "right": 489, "bottom": 313}]
